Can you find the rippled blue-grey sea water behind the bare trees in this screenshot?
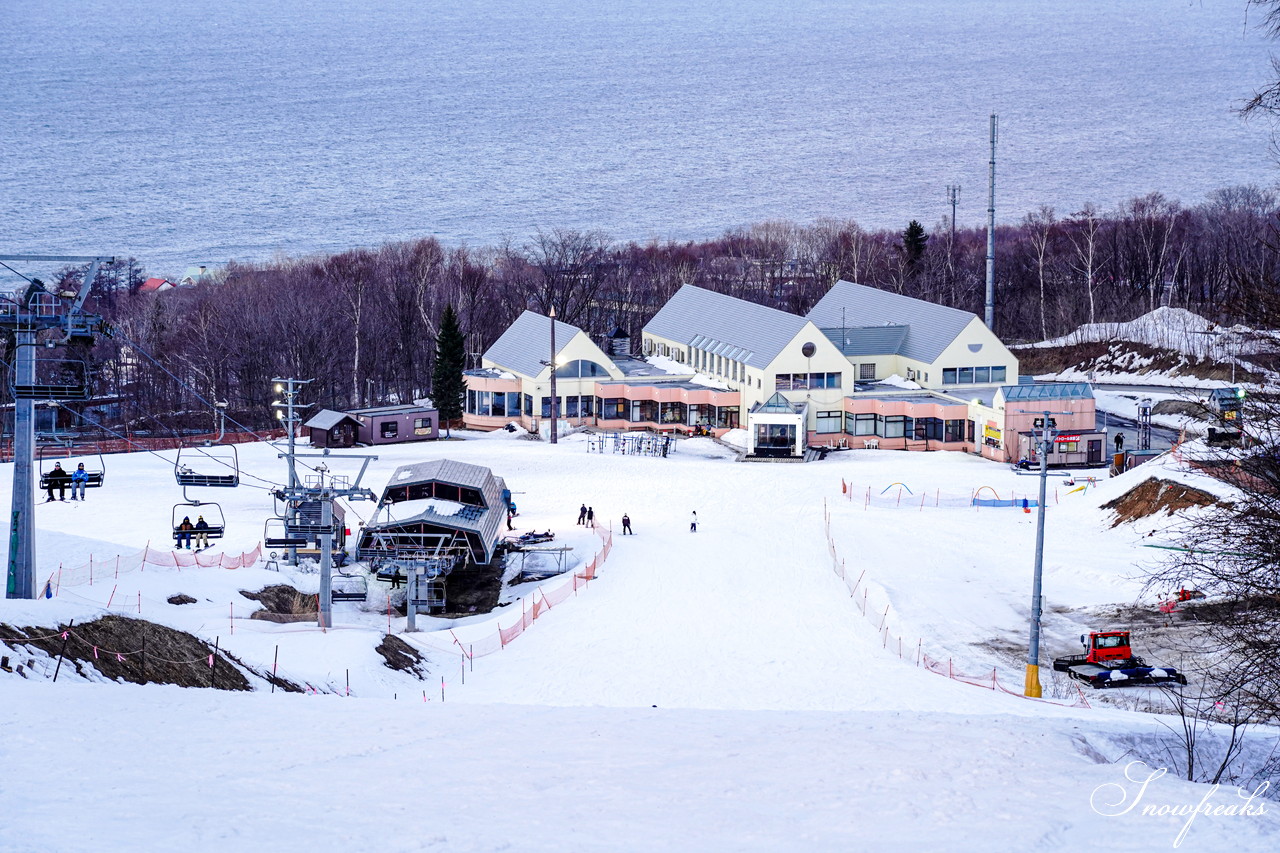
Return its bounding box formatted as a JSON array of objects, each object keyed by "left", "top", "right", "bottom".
[{"left": 0, "top": 0, "right": 1275, "bottom": 275}]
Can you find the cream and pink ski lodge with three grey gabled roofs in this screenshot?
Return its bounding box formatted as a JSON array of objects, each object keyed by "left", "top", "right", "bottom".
[{"left": 463, "top": 280, "right": 1106, "bottom": 465}]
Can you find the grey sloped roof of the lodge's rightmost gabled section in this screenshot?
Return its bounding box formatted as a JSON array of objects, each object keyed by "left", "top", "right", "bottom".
[{"left": 806, "top": 280, "right": 977, "bottom": 362}]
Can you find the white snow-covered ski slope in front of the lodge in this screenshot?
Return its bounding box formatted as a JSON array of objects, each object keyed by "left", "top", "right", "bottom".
[{"left": 0, "top": 433, "right": 1280, "bottom": 850}]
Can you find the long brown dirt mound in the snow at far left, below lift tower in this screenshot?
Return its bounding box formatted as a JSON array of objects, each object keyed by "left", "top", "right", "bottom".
[{"left": 0, "top": 616, "right": 257, "bottom": 690}]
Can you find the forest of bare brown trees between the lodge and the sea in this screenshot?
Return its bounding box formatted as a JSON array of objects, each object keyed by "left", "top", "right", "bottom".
[{"left": 20, "top": 187, "right": 1280, "bottom": 433}]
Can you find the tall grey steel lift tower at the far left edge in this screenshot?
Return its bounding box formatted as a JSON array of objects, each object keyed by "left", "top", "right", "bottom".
[{"left": 0, "top": 255, "right": 115, "bottom": 598}]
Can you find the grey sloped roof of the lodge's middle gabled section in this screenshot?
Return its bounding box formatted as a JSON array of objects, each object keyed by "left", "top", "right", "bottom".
[{"left": 644, "top": 284, "right": 805, "bottom": 368}]
